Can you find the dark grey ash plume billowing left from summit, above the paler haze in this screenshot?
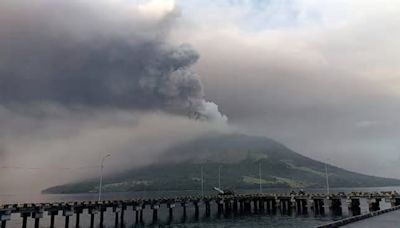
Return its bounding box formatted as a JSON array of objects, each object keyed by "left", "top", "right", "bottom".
[{"left": 0, "top": 0, "right": 226, "bottom": 122}]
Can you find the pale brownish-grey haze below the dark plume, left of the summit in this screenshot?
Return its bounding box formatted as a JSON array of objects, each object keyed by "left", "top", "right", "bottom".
[{"left": 0, "top": 105, "right": 229, "bottom": 192}]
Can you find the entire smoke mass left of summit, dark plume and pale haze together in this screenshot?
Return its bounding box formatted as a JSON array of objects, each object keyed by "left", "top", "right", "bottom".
[{"left": 0, "top": 0, "right": 227, "bottom": 193}]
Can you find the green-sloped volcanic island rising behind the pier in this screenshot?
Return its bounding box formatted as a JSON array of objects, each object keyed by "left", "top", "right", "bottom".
[{"left": 43, "top": 133, "right": 400, "bottom": 193}]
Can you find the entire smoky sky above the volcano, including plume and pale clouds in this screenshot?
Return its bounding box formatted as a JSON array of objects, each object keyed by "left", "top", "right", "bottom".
[{"left": 0, "top": 0, "right": 400, "bottom": 192}]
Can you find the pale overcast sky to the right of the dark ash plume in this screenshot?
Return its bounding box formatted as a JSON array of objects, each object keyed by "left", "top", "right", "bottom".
[{"left": 177, "top": 0, "right": 400, "bottom": 177}]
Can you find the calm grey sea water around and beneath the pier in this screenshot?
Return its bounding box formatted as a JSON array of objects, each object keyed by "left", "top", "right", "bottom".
[{"left": 0, "top": 187, "right": 400, "bottom": 228}]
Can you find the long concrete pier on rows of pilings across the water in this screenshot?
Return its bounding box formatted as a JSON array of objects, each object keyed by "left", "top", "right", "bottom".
[{"left": 0, "top": 192, "right": 400, "bottom": 228}]
